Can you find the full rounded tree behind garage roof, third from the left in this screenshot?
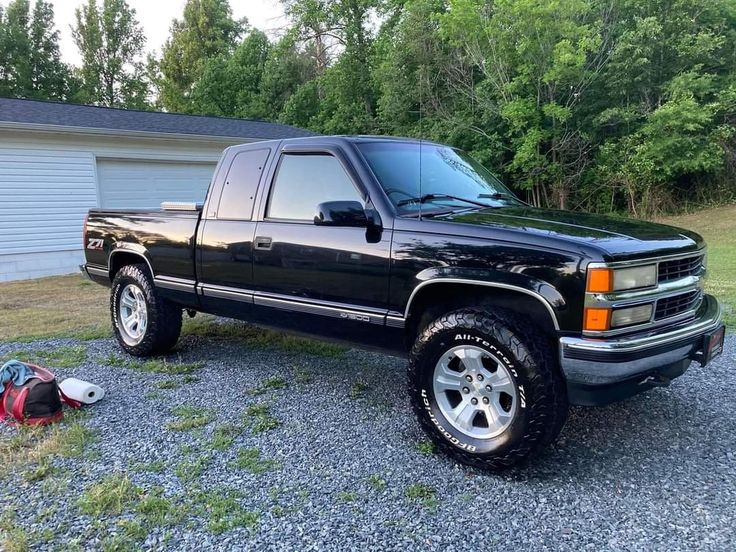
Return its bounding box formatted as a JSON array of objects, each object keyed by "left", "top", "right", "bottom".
[{"left": 159, "top": 0, "right": 246, "bottom": 112}]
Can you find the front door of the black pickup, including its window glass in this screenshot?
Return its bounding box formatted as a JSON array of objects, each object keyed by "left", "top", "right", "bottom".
[{"left": 253, "top": 152, "right": 391, "bottom": 337}]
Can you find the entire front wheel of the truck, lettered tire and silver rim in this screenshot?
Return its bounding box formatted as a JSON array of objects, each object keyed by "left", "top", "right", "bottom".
[{"left": 409, "top": 309, "right": 568, "bottom": 470}]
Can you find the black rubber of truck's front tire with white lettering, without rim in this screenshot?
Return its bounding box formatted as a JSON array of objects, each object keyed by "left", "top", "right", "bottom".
[{"left": 408, "top": 309, "right": 568, "bottom": 471}]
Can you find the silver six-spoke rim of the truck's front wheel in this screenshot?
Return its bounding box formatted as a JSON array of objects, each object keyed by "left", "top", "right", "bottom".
[{"left": 433, "top": 345, "right": 518, "bottom": 439}]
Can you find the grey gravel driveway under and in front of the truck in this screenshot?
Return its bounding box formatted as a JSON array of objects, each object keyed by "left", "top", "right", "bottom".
[{"left": 0, "top": 330, "right": 736, "bottom": 551}]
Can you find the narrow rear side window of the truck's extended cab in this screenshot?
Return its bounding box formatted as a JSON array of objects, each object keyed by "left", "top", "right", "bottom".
[{"left": 217, "top": 149, "right": 271, "bottom": 220}]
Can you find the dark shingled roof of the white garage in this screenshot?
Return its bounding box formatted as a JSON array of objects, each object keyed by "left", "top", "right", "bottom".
[{"left": 0, "top": 98, "right": 314, "bottom": 140}]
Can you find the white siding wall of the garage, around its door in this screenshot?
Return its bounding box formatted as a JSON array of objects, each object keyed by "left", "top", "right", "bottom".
[{"left": 0, "top": 129, "right": 247, "bottom": 282}]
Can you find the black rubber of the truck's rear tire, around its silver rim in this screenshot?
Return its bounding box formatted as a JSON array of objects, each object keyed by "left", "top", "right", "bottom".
[{"left": 110, "top": 264, "right": 182, "bottom": 357}]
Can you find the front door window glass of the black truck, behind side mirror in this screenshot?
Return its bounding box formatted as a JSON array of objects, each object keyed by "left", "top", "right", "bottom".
[{"left": 266, "top": 154, "right": 363, "bottom": 221}]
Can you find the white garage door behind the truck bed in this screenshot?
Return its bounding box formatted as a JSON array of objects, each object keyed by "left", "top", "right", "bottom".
[{"left": 97, "top": 159, "right": 215, "bottom": 209}]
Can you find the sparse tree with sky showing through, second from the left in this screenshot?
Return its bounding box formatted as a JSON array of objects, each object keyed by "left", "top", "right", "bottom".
[{"left": 72, "top": 0, "right": 148, "bottom": 108}]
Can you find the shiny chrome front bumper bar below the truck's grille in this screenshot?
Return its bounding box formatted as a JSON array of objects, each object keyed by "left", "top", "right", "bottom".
[{"left": 560, "top": 295, "right": 721, "bottom": 359}]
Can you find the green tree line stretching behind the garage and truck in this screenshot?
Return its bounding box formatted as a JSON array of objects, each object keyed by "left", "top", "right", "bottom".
[{"left": 0, "top": 0, "right": 736, "bottom": 218}]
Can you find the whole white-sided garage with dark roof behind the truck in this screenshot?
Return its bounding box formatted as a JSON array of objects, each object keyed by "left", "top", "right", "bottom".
[{"left": 0, "top": 98, "right": 312, "bottom": 282}]
